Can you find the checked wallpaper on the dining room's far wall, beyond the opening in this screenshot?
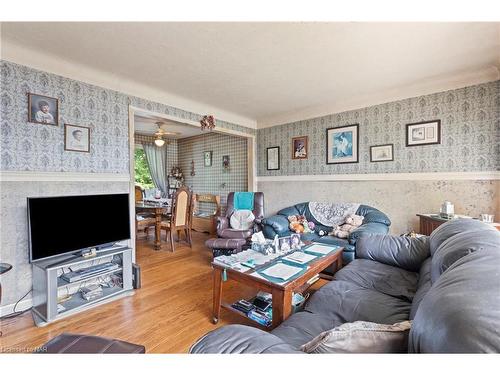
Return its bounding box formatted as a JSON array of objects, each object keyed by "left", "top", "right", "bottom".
[{"left": 178, "top": 133, "right": 248, "bottom": 211}]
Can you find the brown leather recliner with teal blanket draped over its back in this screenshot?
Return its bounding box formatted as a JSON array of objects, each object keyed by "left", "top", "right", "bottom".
[{"left": 217, "top": 192, "right": 264, "bottom": 240}]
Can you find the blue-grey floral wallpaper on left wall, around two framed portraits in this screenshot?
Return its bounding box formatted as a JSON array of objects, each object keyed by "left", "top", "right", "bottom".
[{"left": 0, "top": 60, "right": 255, "bottom": 173}]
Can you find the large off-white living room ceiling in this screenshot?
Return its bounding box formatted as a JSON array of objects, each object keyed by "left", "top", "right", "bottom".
[{"left": 2, "top": 23, "right": 500, "bottom": 123}]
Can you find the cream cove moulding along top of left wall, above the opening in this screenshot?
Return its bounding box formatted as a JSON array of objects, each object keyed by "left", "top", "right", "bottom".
[{"left": 0, "top": 37, "right": 257, "bottom": 129}]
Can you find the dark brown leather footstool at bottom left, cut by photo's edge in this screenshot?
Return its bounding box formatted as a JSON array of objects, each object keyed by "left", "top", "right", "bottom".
[{"left": 36, "top": 333, "right": 146, "bottom": 354}]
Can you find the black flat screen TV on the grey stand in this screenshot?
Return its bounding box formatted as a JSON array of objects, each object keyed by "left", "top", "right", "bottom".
[{"left": 28, "top": 194, "right": 130, "bottom": 262}]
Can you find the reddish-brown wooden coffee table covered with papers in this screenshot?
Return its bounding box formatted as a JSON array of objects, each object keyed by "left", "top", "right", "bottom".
[{"left": 212, "top": 247, "right": 343, "bottom": 330}]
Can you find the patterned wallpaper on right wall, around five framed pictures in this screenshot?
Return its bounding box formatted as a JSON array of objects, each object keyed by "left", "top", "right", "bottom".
[{"left": 257, "top": 81, "right": 500, "bottom": 176}]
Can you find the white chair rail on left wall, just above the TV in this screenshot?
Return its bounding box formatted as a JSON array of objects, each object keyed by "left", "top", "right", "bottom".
[{"left": 0, "top": 171, "right": 130, "bottom": 182}]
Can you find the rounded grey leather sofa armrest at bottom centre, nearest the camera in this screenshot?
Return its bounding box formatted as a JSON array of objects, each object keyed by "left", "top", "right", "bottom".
[{"left": 189, "top": 324, "right": 303, "bottom": 354}]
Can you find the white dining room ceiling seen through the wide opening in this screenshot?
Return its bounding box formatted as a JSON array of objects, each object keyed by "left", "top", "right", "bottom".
[{"left": 134, "top": 113, "right": 203, "bottom": 139}]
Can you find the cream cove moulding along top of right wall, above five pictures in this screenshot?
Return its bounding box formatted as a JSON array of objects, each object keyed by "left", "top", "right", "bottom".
[{"left": 257, "top": 66, "right": 500, "bottom": 129}]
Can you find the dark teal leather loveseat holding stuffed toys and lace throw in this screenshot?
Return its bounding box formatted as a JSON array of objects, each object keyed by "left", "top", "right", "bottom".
[{"left": 262, "top": 202, "right": 391, "bottom": 263}]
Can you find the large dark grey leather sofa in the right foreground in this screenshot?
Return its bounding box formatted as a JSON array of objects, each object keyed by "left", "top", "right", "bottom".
[{"left": 190, "top": 219, "right": 500, "bottom": 353}]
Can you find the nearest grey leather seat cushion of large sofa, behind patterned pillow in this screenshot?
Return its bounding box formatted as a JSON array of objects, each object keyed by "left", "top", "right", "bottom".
[{"left": 304, "top": 280, "right": 411, "bottom": 328}]
